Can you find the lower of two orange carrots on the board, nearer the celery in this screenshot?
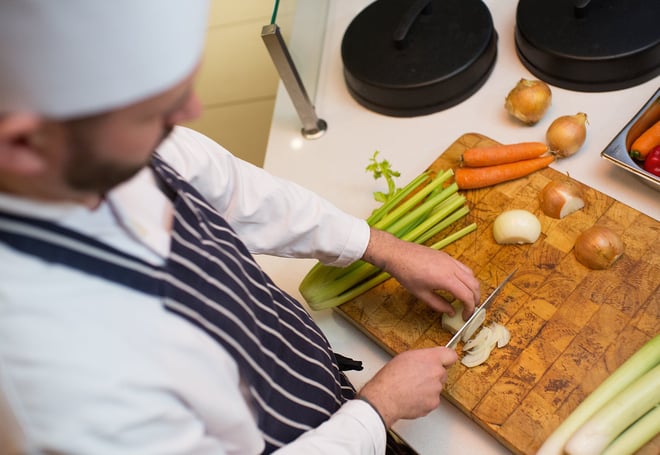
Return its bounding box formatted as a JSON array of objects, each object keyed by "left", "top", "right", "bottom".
[{"left": 454, "top": 155, "right": 555, "bottom": 190}]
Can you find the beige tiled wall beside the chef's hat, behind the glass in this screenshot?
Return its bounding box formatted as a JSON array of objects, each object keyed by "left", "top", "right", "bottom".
[{"left": 187, "top": 0, "right": 286, "bottom": 166}]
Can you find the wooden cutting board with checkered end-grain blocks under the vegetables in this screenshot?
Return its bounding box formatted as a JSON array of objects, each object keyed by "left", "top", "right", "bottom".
[{"left": 336, "top": 133, "right": 660, "bottom": 454}]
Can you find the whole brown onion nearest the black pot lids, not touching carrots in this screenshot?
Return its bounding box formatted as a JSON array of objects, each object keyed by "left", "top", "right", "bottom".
[{"left": 504, "top": 79, "right": 552, "bottom": 125}]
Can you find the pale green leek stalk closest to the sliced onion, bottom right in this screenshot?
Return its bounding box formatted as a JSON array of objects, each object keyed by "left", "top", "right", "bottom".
[{"left": 537, "top": 335, "right": 660, "bottom": 455}]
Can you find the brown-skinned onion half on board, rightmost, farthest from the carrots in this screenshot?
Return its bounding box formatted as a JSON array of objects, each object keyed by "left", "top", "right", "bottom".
[{"left": 573, "top": 225, "right": 624, "bottom": 270}]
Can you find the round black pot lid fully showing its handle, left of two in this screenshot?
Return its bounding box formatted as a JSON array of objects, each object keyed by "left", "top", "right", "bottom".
[{"left": 341, "top": 0, "right": 497, "bottom": 117}]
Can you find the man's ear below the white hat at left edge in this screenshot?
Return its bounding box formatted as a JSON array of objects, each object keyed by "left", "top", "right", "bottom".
[{"left": 0, "top": 114, "right": 46, "bottom": 175}]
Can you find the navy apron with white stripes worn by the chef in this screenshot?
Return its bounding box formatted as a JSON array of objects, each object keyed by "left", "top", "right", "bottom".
[{"left": 0, "top": 157, "right": 355, "bottom": 453}]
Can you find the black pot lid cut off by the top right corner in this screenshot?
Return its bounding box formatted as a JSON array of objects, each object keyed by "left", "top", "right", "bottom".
[{"left": 515, "top": 0, "right": 660, "bottom": 92}]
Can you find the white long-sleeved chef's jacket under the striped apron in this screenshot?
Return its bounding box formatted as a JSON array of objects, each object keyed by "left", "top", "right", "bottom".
[{"left": 0, "top": 127, "right": 385, "bottom": 455}]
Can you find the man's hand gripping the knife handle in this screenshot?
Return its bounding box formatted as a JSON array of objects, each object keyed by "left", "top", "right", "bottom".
[{"left": 359, "top": 347, "right": 458, "bottom": 428}]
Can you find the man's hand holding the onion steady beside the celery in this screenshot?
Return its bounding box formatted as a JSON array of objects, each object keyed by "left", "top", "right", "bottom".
[{"left": 362, "top": 228, "right": 481, "bottom": 320}]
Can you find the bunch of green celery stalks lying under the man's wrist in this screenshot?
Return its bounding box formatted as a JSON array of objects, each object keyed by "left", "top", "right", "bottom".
[{"left": 299, "top": 169, "right": 476, "bottom": 310}]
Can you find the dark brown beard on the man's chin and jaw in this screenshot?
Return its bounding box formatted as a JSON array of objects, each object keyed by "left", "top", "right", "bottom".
[{"left": 65, "top": 127, "right": 173, "bottom": 195}]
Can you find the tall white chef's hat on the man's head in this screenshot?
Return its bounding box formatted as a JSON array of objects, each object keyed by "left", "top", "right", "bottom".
[{"left": 0, "top": 0, "right": 208, "bottom": 119}]
